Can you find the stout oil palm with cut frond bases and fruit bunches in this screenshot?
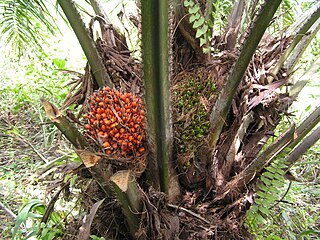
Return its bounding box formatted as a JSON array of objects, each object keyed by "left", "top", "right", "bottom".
[{"left": 5, "top": 0, "right": 320, "bottom": 239}]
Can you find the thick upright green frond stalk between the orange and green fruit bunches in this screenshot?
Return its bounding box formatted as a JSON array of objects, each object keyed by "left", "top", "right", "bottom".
[{"left": 141, "top": 0, "right": 172, "bottom": 193}]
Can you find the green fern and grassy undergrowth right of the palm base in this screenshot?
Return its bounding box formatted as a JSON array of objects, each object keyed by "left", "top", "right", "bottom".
[{"left": 246, "top": 110, "right": 320, "bottom": 240}]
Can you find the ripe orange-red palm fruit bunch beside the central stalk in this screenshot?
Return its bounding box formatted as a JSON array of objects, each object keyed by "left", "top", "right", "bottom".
[{"left": 84, "top": 87, "right": 145, "bottom": 157}]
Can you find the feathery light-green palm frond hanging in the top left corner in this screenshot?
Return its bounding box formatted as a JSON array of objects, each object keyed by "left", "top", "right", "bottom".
[{"left": 0, "top": 0, "right": 58, "bottom": 54}]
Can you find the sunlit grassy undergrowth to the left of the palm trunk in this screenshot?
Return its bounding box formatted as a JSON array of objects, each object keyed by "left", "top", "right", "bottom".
[{"left": 0, "top": 38, "right": 84, "bottom": 239}]
